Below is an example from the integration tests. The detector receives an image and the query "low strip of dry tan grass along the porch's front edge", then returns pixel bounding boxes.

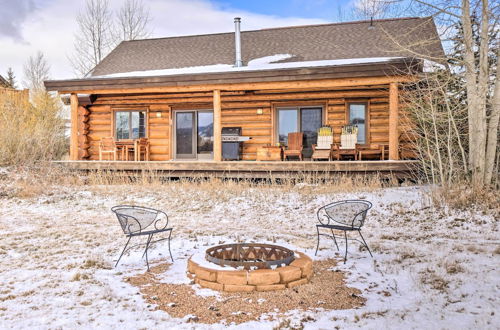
[0,162,394,198]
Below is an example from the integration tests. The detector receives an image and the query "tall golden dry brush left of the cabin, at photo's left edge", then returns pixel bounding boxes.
[0,92,68,166]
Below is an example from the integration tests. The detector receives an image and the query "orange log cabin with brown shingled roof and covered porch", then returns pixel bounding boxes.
[45,17,443,175]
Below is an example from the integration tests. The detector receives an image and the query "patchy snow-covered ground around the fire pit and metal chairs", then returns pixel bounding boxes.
[0,183,500,329]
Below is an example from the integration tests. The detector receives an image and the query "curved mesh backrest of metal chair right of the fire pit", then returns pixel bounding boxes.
[317,200,372,228]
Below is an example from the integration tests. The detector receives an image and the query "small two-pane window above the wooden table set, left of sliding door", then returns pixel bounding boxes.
[115,111,146,140]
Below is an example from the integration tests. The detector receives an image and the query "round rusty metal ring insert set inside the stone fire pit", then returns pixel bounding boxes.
[205,243,295,270]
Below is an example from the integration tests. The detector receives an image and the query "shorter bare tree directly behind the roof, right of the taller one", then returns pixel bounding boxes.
[118,0,151,40]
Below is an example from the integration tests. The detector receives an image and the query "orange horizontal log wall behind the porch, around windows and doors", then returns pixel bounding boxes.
[89,86,404,160]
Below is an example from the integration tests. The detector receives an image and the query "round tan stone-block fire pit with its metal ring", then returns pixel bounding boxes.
[188,243,313,292]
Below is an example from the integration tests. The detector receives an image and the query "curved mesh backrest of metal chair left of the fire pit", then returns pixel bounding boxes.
[111,205,168,235]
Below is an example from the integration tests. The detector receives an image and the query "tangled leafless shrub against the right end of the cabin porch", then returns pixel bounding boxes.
[401,71,469,185]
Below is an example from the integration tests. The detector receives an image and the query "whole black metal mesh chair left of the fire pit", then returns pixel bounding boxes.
[111,205,174,271]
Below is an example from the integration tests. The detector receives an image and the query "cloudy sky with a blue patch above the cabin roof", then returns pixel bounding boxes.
[0,0,384,87]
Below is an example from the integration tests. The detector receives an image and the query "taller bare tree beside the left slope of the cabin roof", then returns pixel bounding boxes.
[70,0,116,76]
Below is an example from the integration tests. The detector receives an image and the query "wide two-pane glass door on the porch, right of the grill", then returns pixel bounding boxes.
[278,107,322,157]
